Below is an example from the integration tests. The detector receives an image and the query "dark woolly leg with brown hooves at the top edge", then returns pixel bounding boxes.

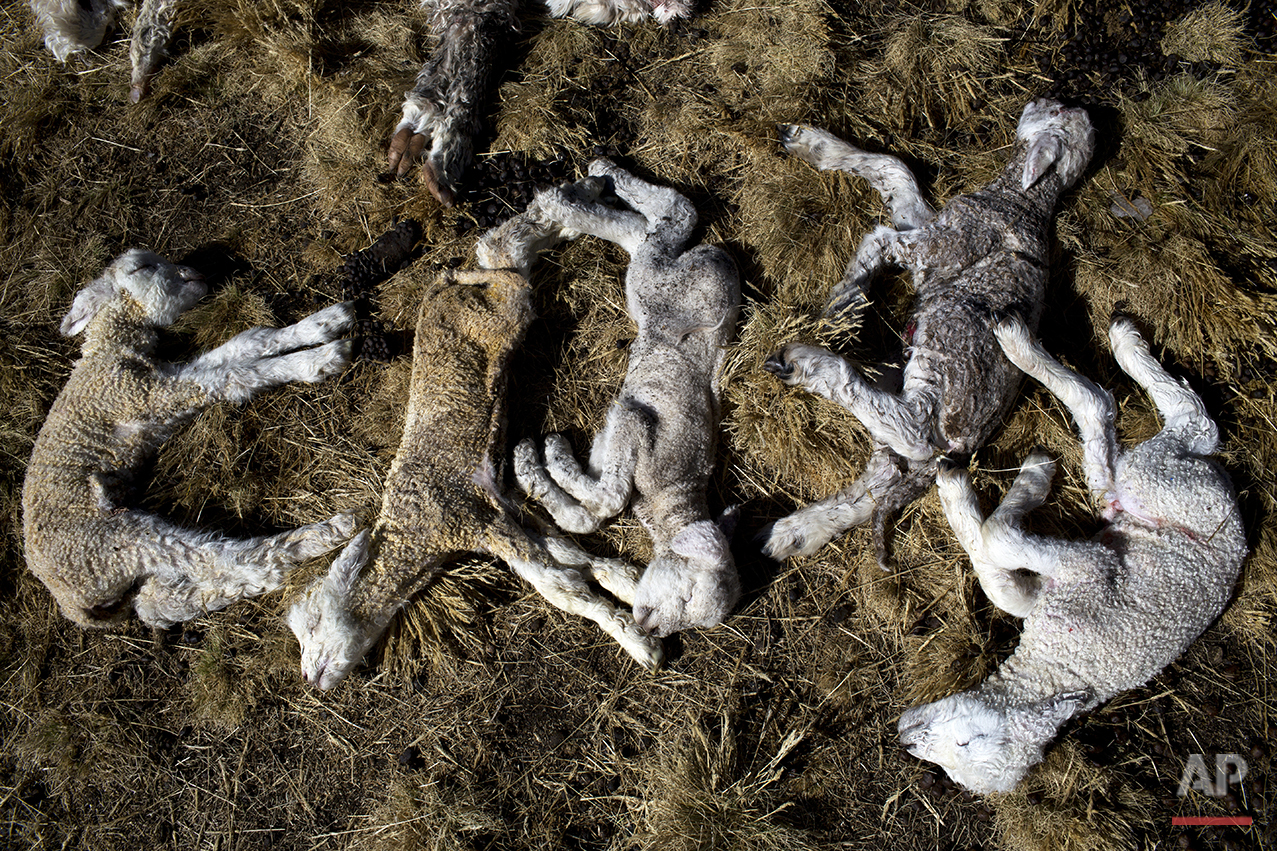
[387,0,518,207]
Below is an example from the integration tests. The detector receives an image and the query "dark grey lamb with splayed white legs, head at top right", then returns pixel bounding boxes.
[761,100,1094,570]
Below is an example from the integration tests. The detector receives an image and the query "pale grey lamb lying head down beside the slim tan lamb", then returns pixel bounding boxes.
[515,160,741,636]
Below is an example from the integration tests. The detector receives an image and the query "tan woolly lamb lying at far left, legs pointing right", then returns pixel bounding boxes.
[22,249,355,627]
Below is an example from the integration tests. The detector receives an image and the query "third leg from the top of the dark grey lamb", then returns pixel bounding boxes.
[762,344,935,461]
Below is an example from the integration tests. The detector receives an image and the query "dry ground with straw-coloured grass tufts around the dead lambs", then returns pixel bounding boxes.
[0,0,1277,851]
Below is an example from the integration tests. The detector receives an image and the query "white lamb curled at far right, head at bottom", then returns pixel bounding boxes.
[899,318,1246,792]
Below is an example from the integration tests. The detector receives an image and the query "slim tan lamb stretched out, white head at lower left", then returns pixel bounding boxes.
[289,181,663,690]
